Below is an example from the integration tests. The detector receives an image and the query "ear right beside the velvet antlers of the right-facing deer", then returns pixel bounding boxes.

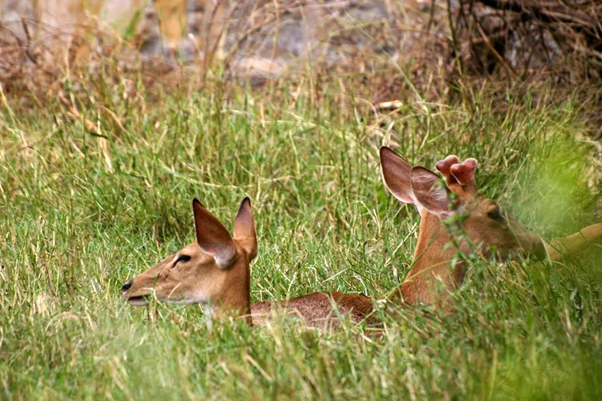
[411,166,451,218]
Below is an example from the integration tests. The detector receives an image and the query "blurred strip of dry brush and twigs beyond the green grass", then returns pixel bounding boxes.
[0,0,602,102]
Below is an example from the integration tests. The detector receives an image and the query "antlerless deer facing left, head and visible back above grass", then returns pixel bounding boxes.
[121,197,372,328]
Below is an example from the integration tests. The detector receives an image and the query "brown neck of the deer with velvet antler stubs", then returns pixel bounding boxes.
[400,209,466,304]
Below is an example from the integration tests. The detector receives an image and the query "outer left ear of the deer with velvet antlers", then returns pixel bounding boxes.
[380,146,415,203]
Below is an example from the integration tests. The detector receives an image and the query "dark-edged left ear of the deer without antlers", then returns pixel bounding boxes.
[192,199,236,268]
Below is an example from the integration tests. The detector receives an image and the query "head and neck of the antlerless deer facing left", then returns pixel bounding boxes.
[121,198,257,323]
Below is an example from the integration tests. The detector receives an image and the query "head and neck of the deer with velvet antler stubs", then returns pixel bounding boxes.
[380,147,546,303]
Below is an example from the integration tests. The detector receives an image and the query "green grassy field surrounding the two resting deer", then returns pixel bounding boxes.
[0,72,602,400]
